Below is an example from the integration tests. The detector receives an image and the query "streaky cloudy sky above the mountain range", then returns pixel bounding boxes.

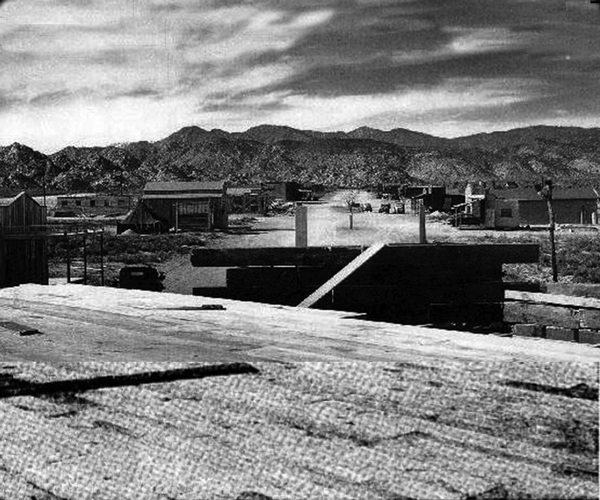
[0,0,600,152]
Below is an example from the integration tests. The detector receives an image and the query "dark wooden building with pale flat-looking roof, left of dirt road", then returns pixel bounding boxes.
[142,181,228,231]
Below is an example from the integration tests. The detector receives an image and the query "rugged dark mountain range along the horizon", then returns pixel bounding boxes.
[0,125,600,195]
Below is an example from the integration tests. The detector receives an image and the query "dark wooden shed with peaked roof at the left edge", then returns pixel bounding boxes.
[0,192,48,287]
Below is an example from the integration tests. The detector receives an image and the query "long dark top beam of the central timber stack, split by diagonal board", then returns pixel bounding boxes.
[191,243,539,267]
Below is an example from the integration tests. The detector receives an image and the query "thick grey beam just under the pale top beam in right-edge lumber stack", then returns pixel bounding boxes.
[504,302,579,328]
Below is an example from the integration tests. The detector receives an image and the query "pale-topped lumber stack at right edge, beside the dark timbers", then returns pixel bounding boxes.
[504,290,600,344]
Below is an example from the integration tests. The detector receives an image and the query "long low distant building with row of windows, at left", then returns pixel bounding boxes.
[51,193,134,217]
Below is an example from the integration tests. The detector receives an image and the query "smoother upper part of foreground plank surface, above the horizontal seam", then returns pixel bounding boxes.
[0,285,600,362]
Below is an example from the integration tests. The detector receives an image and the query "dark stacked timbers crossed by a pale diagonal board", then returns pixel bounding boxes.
[191,244,539,325]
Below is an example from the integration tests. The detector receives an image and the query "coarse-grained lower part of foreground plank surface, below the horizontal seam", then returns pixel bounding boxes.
[0,356,598,500]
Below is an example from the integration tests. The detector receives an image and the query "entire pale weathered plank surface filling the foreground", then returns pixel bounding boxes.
[0,285,599,500]
